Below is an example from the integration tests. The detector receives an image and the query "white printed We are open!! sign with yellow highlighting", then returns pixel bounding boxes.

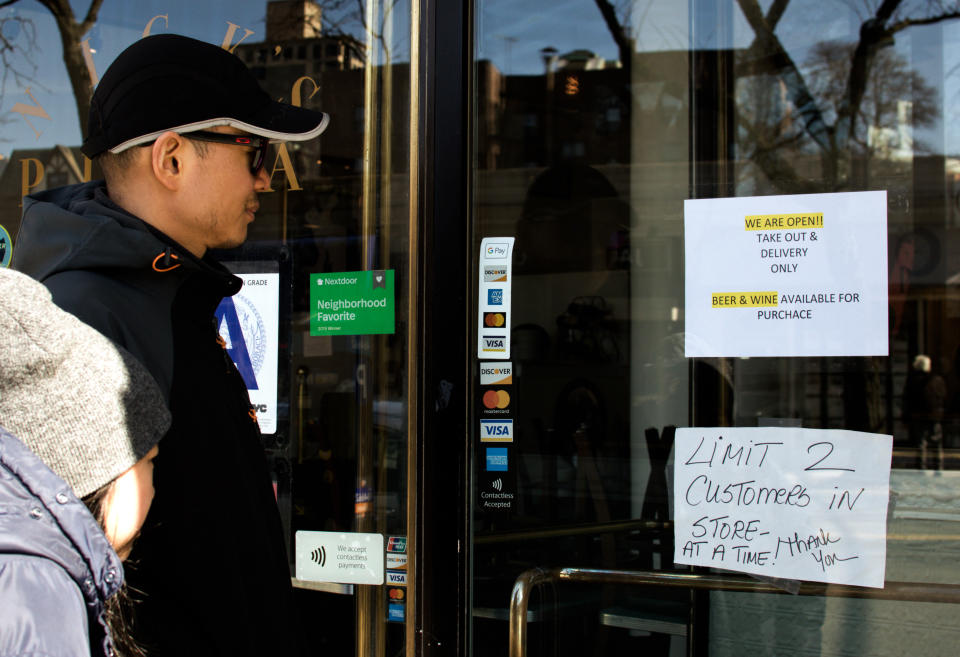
[684,191,888,357]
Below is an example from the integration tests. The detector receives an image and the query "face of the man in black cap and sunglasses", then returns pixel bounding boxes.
[181,127,270,252]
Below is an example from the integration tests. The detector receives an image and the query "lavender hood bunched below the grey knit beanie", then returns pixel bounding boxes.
[0,427,123,606]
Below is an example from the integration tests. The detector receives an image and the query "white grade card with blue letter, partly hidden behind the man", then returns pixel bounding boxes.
[216,273,280,434]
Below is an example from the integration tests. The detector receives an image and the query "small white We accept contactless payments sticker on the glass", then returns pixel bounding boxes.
[294,531,383,584]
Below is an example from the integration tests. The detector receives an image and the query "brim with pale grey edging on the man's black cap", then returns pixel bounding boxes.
[110,101,330,153]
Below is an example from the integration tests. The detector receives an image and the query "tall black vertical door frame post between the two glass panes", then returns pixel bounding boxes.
[406,0,473,656]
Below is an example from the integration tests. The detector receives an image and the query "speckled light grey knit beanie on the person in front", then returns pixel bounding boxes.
[0,269,170,497]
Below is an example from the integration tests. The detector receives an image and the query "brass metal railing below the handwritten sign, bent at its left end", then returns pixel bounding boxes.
[510,568,960,657]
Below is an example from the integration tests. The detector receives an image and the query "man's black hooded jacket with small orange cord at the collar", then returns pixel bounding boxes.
[13,181,298,657]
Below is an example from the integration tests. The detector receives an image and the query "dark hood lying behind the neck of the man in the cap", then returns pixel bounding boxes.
[14,180,170,280]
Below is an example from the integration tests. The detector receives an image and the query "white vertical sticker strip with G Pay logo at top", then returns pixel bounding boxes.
[477,237,514,360]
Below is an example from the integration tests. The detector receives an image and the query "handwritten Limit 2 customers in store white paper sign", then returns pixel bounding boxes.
[673,427,893,588]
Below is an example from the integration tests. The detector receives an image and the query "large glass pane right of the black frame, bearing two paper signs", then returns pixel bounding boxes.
[471,0,960,655]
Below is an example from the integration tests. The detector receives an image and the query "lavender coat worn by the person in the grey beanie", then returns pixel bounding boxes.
[0,427,123,657]
